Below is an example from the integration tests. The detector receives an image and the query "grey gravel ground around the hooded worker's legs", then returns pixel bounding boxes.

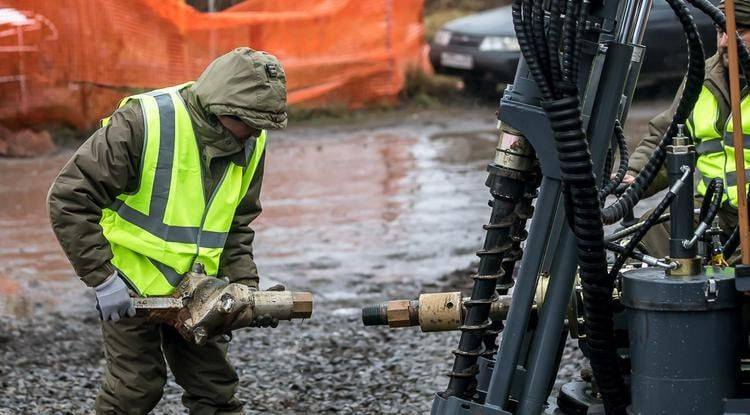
[0,272,581,414]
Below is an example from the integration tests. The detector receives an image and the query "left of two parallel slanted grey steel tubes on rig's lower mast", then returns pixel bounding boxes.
[486,177,562,408]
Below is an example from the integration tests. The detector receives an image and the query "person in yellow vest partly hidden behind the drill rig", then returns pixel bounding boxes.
[623,0,750,259]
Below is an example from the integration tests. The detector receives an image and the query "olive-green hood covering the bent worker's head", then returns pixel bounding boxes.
[186,47,287,158]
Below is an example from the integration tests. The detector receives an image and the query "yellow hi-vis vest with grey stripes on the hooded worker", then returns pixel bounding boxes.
[100,83,266,296]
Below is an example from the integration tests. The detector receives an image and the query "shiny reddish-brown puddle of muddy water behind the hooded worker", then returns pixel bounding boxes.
[0,118,506,315]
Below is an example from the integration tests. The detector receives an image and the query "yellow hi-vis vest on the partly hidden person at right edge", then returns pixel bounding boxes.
[687,85,750,208]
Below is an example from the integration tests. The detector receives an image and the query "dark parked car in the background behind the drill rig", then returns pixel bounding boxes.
[430,0,716,92]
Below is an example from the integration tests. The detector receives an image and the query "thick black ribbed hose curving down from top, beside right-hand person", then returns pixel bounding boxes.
[602,0,705,225]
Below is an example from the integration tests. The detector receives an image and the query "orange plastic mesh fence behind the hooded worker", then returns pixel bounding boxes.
[0,0,423,128]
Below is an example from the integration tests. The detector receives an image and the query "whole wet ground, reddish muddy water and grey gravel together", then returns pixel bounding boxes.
[0,97,667,414]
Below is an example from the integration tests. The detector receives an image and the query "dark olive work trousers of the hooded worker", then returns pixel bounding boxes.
[96,317,243,415]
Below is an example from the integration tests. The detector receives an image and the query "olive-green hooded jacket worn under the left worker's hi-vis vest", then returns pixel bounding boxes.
[47,48,286,287]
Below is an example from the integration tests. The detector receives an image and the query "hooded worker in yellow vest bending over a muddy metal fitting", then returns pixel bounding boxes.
[49,48,286,414]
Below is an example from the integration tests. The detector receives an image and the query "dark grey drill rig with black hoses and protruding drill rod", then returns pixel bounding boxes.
[363,0,750,415]
